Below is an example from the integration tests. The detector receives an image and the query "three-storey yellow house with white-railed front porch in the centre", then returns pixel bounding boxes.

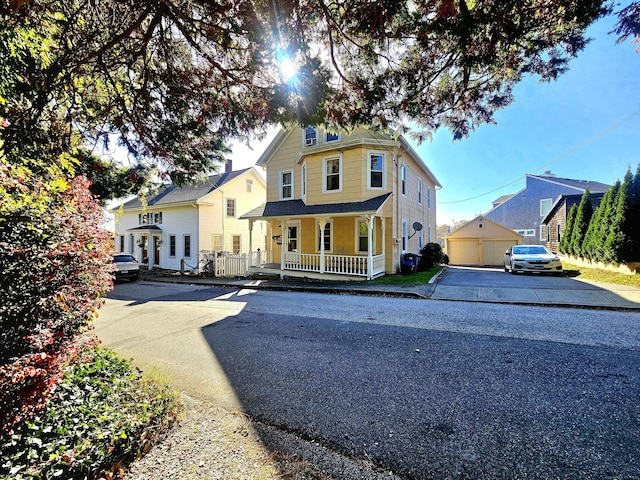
[243,127,440,279]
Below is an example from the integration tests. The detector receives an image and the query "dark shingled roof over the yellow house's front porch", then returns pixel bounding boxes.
[240,193,391,219]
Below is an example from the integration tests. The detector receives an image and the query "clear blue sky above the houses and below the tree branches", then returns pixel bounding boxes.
[230,9,640,224]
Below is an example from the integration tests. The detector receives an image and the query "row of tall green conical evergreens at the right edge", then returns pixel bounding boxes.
[558,165,640,264]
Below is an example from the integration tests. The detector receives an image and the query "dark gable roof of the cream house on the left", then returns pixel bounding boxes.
[123,167,262,210]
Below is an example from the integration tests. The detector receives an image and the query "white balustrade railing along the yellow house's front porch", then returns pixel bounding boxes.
[284,253,384,278]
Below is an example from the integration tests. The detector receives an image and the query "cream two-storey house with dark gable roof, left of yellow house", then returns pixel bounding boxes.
[112,161,266,272]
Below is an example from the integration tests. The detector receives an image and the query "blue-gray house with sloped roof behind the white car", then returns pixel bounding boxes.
[484,171,610,245]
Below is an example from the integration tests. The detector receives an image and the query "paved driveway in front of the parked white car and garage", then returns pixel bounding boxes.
[431,266,640,309]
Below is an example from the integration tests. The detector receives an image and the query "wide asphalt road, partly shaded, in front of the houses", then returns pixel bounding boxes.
[96,284,640,479]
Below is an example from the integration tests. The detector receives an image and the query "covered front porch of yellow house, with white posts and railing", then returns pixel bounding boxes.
[243,195,388,280]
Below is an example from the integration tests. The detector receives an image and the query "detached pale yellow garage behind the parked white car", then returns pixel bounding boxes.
[444,216,522,266]
